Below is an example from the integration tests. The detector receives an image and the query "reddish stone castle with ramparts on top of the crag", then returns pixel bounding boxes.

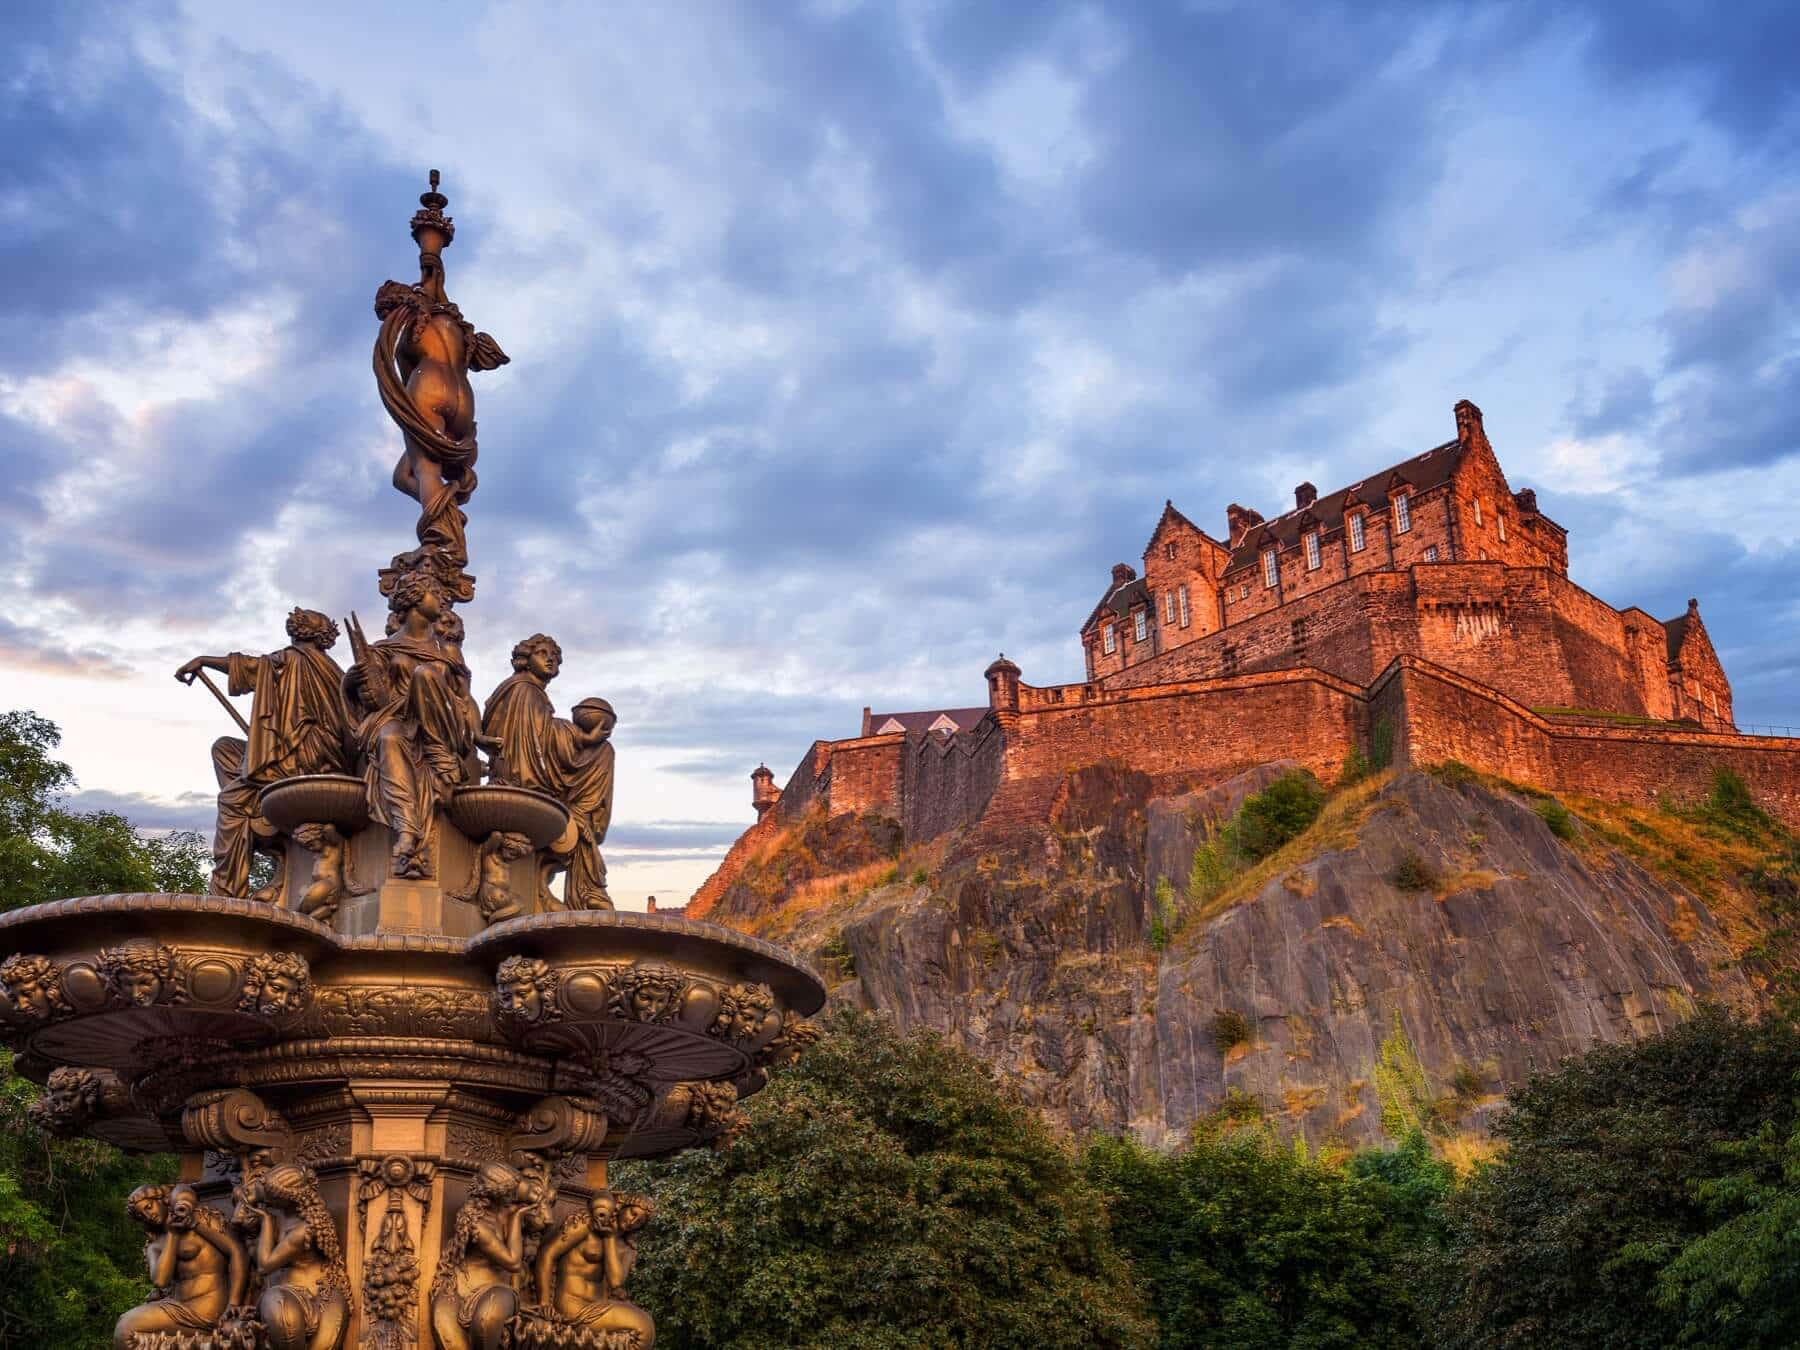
[695,401,1778,913]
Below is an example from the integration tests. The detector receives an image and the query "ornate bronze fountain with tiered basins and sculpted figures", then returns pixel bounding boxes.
[0,171,824,1350]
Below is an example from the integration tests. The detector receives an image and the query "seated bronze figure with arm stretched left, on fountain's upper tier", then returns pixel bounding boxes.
[175,608,351,896]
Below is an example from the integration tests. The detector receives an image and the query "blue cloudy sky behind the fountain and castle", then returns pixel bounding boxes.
[0,0,1800,905]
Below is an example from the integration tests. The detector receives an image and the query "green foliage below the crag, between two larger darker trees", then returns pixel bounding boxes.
[1085,1129,1451,1350]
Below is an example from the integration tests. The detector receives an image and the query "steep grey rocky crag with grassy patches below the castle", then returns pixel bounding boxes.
[706,763,1791,1147]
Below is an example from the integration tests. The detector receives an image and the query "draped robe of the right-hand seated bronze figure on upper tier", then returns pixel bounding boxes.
[481,671,614,909]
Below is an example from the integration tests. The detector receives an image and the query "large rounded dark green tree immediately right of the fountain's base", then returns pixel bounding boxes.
[616,1013,1154,1350]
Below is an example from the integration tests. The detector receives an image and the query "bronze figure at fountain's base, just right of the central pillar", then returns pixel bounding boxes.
[430,1163,538,1350]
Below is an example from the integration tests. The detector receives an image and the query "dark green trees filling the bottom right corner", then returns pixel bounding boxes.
[1436,1010,1800,1350]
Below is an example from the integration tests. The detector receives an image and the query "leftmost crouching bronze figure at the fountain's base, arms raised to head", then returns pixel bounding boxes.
[113,1184,250,1350]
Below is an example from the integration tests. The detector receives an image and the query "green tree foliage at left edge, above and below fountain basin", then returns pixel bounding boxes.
[0,713,205,1346]
